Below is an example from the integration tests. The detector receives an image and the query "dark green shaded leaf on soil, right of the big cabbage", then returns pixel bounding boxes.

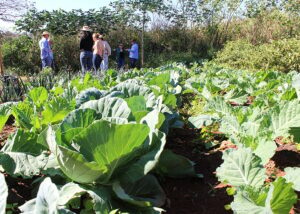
[155,150,203,178]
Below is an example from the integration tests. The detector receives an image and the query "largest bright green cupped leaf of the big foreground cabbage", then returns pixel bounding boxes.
[52,121,149,183]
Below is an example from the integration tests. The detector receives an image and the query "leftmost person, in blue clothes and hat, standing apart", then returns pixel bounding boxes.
[39,31,52,68]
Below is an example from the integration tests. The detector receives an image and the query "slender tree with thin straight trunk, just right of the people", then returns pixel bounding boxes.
[111,0,169,66]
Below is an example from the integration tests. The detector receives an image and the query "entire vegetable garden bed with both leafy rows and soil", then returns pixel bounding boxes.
[0,65,300,214]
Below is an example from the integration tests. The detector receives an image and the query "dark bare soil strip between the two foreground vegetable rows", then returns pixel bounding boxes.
[162,129,233,214]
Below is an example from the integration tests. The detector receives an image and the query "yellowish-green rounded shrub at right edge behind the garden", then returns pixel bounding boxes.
[213,38,300,72]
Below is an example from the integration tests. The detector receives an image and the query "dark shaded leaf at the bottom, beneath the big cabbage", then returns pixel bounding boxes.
[113,175,166,207]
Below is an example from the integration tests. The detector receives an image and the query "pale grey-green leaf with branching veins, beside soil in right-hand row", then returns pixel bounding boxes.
[217,148,266,187]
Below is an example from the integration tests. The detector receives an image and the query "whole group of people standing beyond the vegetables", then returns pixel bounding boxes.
[39,26,139,74]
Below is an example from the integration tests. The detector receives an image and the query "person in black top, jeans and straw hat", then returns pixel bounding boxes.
[79,26,94,74]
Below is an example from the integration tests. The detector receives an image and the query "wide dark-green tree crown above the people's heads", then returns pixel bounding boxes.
[16,7,118,35]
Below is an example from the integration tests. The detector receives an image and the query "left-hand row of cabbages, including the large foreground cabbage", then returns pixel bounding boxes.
[0,69,199,214]
